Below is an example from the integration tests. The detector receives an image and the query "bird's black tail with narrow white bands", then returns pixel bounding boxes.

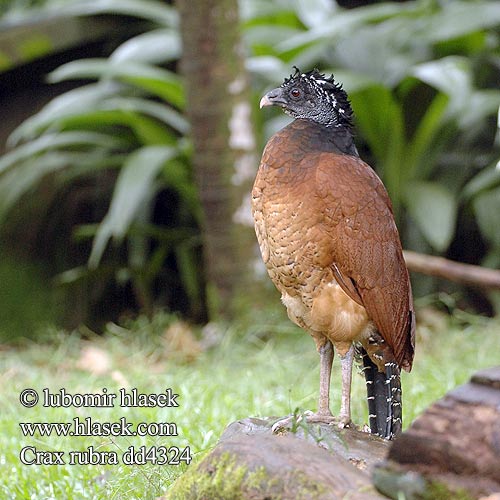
[360,348,403,439]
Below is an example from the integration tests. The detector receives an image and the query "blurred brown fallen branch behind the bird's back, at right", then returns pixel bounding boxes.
[404,250,500,289]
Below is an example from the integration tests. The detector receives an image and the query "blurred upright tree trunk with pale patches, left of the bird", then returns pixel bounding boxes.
[177,0,257,319]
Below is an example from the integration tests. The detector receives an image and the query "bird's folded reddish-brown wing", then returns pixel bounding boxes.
[316,153,414,370]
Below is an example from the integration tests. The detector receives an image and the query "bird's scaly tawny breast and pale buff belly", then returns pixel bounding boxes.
[252,153,370,350]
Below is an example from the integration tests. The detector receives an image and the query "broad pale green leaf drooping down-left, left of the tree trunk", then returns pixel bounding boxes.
[89,146,177,268]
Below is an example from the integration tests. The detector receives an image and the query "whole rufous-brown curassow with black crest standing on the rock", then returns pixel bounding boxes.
[252,68,415,439]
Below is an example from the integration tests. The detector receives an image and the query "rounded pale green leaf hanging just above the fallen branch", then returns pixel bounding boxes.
[405,182,457,252]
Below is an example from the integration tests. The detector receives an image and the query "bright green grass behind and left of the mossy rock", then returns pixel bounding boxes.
[0,312,500,500]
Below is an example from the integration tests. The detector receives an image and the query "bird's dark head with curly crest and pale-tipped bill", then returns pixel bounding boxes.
[260,67,352,129]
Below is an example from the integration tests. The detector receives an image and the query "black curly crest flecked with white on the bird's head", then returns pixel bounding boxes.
[281,66,354,129]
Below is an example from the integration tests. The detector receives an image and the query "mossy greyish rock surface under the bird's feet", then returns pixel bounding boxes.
[167,419,388,500]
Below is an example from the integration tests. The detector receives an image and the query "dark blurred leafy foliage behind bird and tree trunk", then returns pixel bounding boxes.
[0,0,500,335]
